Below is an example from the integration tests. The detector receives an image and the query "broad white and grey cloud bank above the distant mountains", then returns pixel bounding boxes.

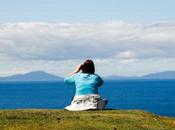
[0,21,175,75]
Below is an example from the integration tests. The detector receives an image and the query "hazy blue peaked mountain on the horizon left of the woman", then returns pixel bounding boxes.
[0,71,63,81]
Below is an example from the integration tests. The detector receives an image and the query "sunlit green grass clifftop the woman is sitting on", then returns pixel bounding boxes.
[0,109,175,130]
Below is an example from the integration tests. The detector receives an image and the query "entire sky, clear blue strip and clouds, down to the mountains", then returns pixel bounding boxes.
[0,0,175,76]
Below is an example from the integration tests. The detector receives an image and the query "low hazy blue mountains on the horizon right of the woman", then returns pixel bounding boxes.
[105,71,175,80]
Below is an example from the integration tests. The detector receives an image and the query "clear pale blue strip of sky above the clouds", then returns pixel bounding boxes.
[0,0,175,23]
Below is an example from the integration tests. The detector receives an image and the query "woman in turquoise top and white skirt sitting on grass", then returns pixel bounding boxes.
[64,60,107,111]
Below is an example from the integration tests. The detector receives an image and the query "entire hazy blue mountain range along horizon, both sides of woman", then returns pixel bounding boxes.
[0,71,175,82]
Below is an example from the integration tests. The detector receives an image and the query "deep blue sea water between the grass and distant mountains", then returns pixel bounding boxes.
[0,80,175,117]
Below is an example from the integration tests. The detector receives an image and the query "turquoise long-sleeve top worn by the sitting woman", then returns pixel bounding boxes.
[64,73,103,95]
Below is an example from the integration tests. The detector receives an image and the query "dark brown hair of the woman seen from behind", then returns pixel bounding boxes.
[81,59,95,74]
